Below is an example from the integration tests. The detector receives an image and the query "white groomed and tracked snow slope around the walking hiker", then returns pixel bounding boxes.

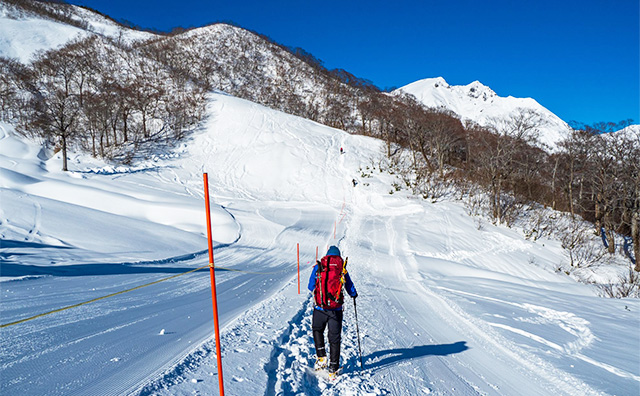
[0,94,640,396]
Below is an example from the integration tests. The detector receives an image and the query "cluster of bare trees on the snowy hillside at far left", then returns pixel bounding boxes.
[0,36,205,170]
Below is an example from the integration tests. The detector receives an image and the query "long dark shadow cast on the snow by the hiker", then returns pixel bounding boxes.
[363,341,469,369]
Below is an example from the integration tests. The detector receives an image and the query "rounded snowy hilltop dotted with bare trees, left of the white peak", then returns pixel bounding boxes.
[149,23,357,114]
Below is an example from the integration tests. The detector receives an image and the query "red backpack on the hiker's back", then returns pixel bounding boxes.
[314,256,345,309]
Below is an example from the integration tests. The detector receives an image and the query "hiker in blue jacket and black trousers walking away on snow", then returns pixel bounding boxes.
[309,246,358,379]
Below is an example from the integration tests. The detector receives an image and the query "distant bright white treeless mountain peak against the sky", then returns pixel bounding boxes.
[398,77,569,150]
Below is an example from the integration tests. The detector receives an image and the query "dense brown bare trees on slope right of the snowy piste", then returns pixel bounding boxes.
[370,100,640,282]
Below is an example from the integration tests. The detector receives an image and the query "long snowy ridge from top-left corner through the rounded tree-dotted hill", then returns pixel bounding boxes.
[0,0,363,132]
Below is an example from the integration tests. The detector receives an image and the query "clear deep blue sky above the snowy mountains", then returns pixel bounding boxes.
[70,0,640,124]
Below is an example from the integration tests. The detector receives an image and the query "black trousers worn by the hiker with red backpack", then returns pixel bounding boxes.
[311,309,342,370]
